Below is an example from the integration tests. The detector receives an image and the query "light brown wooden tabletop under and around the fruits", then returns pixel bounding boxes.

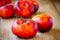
[0,0,60,40]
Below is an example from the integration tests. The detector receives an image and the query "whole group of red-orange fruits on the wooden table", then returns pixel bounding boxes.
[0,0,53,38]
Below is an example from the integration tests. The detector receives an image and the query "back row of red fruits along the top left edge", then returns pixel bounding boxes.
[0,0,39,18]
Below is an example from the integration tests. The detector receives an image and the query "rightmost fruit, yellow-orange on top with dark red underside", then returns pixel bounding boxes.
[32,14,53,32]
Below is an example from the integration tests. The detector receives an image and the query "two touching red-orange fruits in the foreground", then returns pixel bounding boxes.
[12,14,53,38]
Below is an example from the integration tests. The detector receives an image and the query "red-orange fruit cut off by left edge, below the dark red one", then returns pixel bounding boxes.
[0,3,13,18]
